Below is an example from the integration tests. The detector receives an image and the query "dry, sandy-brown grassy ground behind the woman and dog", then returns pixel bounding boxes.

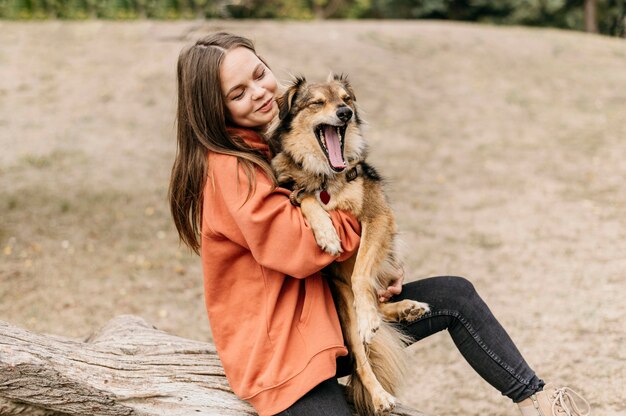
[0,21,626,416]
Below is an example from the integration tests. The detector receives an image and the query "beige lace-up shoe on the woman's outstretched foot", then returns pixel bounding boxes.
[518,384,591,416]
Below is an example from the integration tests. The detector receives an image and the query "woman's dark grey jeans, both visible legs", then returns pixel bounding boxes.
[272,276,544,416]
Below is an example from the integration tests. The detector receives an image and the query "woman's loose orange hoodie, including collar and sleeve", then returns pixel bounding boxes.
[201,129,360,416]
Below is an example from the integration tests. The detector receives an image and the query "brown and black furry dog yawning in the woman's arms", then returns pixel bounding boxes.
[270,75,428,415]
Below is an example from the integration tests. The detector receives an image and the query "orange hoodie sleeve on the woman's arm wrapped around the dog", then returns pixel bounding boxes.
[203,155,361,278]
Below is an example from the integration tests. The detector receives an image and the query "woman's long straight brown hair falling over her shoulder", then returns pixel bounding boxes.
[168,32,276,254]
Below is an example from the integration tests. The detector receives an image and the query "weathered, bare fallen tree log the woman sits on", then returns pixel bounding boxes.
[0,315,424,416]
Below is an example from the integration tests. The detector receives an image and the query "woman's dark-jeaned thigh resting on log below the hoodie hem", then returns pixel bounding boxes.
[276,377,352,416]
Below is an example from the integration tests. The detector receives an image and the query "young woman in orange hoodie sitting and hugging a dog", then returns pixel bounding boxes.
[169,33,588,416]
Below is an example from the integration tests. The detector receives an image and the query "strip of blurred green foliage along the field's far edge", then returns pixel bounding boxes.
[0,0,626,36]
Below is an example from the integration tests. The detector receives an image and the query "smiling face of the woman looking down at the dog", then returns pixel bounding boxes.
[220,47,278,127]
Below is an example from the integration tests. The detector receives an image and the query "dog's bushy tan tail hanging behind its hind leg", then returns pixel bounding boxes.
[348,322,410,415]
